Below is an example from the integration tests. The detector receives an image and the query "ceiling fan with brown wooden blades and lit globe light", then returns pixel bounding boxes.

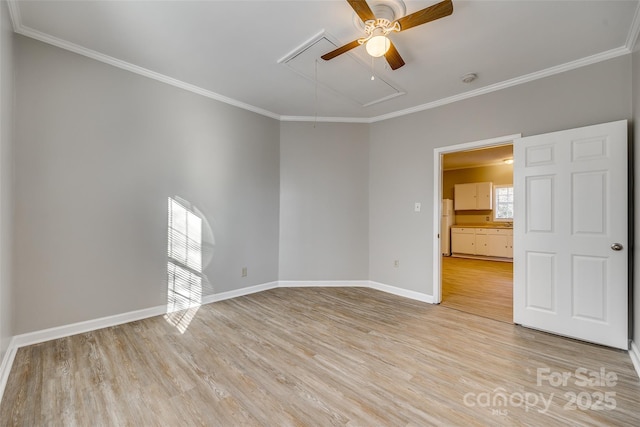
[321,0,453,70]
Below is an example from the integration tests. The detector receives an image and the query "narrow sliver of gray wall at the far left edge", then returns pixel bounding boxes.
[0,1,13,360]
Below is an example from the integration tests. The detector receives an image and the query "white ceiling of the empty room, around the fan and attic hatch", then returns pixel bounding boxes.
[10,0,640,122]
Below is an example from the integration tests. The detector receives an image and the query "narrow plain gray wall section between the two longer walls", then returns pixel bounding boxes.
[280,123,369,280]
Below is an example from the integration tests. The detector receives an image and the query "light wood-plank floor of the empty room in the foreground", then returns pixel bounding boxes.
[0,288,640,427]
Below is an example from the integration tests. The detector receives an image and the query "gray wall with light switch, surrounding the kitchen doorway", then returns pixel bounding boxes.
[369,55,631,294]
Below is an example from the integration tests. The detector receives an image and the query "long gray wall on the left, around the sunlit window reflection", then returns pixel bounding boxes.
[14,36,280,334]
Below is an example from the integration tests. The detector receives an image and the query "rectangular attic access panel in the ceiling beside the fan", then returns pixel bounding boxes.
[278,33,404,107]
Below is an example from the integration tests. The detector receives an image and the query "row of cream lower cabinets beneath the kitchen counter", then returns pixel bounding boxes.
[451,227,513,258]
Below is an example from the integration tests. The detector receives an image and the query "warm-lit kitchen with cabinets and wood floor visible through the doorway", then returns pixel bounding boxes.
[440,144,514,323]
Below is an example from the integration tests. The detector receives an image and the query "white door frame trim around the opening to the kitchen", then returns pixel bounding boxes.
[433,133,522,304]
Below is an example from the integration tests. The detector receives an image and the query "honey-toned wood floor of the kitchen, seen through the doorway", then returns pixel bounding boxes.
[441,257,513,323]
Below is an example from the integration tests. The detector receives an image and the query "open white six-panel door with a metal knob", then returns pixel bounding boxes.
[513,121,629,349]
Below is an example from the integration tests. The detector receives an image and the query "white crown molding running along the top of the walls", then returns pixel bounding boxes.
[7,0,640,124]
